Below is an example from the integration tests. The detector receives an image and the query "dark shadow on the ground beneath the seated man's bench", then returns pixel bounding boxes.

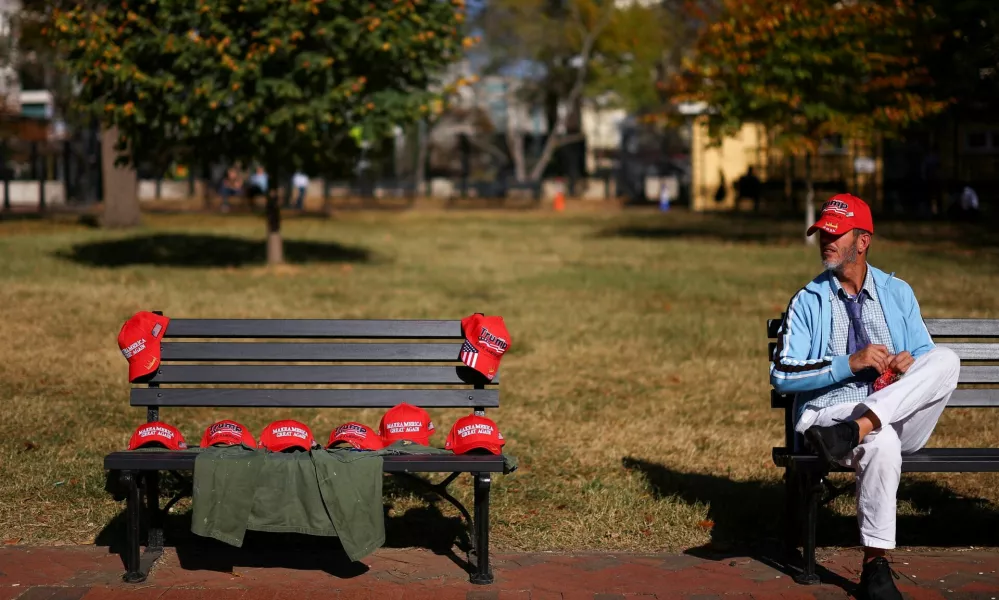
[621,457,999,593]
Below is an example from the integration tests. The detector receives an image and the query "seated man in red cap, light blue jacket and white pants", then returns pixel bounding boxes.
[770,194,960,599]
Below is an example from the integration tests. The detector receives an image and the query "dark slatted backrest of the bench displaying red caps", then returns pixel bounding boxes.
[130,319,499,421]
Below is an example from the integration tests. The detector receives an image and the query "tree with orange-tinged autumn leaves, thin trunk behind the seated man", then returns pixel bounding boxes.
[668,0,949,239]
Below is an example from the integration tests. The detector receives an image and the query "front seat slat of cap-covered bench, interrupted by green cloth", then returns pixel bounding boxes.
[104,451,503,473]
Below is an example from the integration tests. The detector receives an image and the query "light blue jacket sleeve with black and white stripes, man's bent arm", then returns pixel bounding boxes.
[770,289,853,393]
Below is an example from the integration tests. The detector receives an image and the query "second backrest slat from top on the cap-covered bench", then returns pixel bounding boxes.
[162,342,461,362]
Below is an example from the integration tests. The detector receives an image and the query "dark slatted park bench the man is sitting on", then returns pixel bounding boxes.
[767,315,999,584]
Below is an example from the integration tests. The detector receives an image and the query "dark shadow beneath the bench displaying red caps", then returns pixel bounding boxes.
[95,477,474,579]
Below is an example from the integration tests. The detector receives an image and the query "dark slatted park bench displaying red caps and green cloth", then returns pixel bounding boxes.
[104,319,504,584]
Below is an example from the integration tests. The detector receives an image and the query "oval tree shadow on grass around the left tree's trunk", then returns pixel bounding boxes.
[56,233,371,267]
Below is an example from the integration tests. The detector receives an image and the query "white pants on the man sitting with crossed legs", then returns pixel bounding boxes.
[795,347,961,550]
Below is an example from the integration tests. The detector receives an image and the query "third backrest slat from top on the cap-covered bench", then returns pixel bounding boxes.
[149,365,499,385]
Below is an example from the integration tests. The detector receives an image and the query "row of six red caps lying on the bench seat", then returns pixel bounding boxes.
[128,402,506,454]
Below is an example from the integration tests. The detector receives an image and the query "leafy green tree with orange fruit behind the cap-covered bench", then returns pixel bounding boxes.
[46,0,464,264]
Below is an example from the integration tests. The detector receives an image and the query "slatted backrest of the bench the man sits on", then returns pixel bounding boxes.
[767,314,999,449]
